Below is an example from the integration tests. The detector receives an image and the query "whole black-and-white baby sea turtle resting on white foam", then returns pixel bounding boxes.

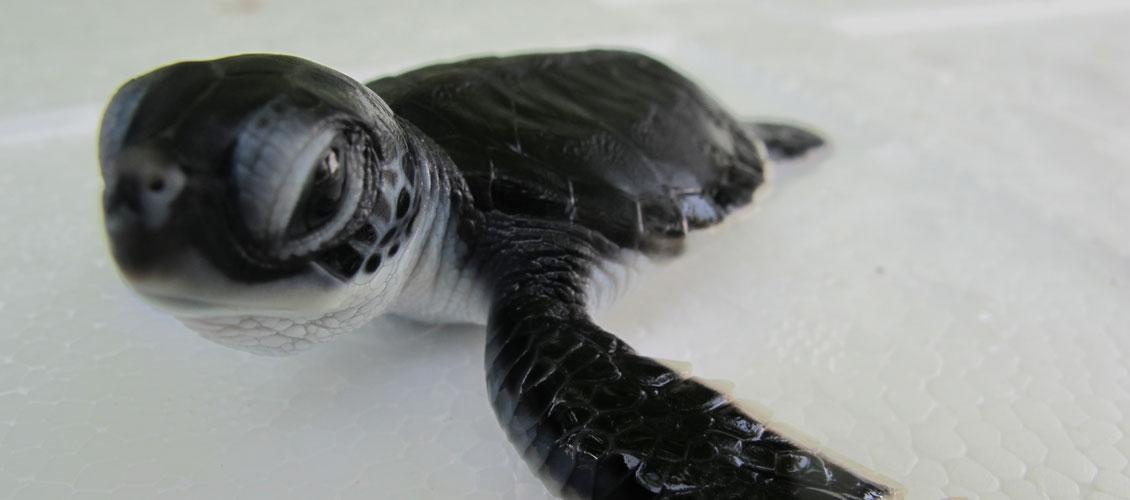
[98,51,890,499]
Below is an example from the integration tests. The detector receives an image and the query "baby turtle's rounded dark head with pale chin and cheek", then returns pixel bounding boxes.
[98,54,421,353]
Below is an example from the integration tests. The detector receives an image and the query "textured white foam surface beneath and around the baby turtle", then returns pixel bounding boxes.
[0,0,1130,499]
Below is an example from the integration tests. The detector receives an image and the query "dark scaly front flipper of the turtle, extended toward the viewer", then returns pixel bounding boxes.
[476,215,890,499]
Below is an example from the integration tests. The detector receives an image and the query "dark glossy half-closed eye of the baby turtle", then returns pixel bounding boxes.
[287,147,348,236]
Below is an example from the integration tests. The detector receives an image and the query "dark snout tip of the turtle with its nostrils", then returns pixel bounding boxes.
[103,143,186,281]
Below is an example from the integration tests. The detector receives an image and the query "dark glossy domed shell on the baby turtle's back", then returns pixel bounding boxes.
[367,51,764,253]
